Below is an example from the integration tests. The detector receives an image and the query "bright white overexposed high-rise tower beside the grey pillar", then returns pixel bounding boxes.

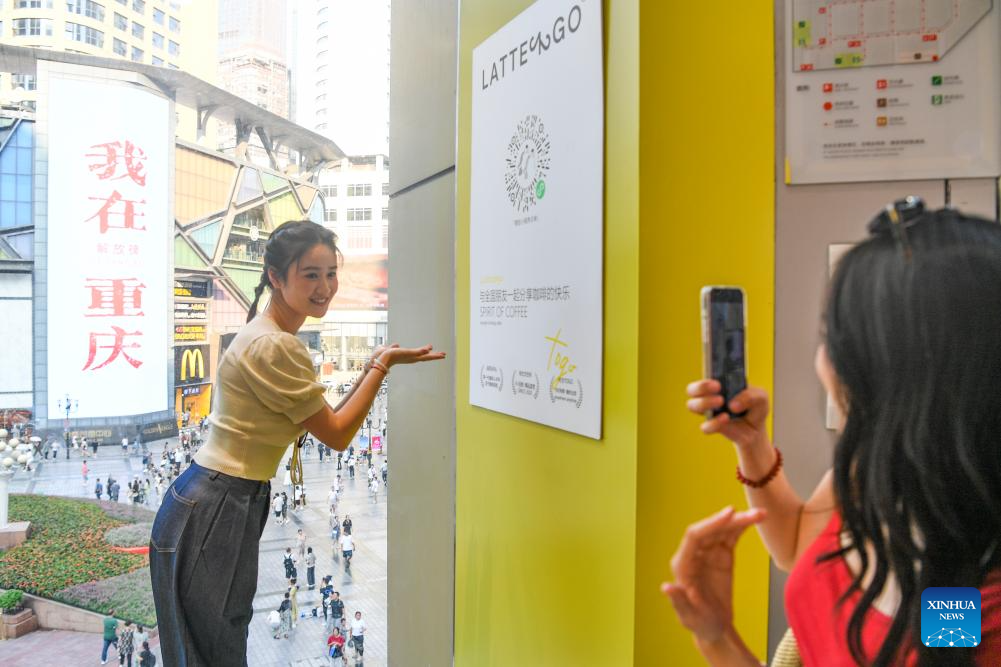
[288,0,389,155]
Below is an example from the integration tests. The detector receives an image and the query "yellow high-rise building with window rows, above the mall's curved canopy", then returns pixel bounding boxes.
[0,0,217,106]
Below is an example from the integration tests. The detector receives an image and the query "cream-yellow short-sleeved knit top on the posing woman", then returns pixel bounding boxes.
[194,315,326,481]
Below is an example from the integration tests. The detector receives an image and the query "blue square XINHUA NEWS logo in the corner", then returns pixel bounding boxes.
[921,587,981,648]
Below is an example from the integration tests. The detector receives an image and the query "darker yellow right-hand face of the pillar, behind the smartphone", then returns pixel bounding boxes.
[636,1,775,665]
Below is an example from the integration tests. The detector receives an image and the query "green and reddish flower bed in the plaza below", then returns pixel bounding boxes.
[0,494,155,625]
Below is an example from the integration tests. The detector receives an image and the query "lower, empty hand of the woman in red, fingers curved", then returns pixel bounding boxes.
[661,507,765,644]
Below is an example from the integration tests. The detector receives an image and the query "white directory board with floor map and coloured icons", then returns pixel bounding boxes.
[786,0,1001,183]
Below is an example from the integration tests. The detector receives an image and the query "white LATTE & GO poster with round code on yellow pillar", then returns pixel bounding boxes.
[469,0,605,439]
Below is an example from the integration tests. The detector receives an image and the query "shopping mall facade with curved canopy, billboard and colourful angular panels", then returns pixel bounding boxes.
[0,45,344,442]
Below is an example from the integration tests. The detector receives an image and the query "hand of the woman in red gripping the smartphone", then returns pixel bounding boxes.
[686,379,769,447]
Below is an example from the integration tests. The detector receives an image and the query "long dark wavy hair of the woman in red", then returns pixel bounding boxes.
[824,209,1001,666]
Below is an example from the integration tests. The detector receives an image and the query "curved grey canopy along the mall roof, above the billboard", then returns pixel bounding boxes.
[0,44,344,171]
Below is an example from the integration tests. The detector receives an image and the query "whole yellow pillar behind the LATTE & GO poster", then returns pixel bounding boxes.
[454,0,774,667]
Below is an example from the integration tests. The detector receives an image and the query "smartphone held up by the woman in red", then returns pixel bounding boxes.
[702,286,748,419]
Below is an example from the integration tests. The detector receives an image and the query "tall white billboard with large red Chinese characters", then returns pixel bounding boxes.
[47,72,173,419]
